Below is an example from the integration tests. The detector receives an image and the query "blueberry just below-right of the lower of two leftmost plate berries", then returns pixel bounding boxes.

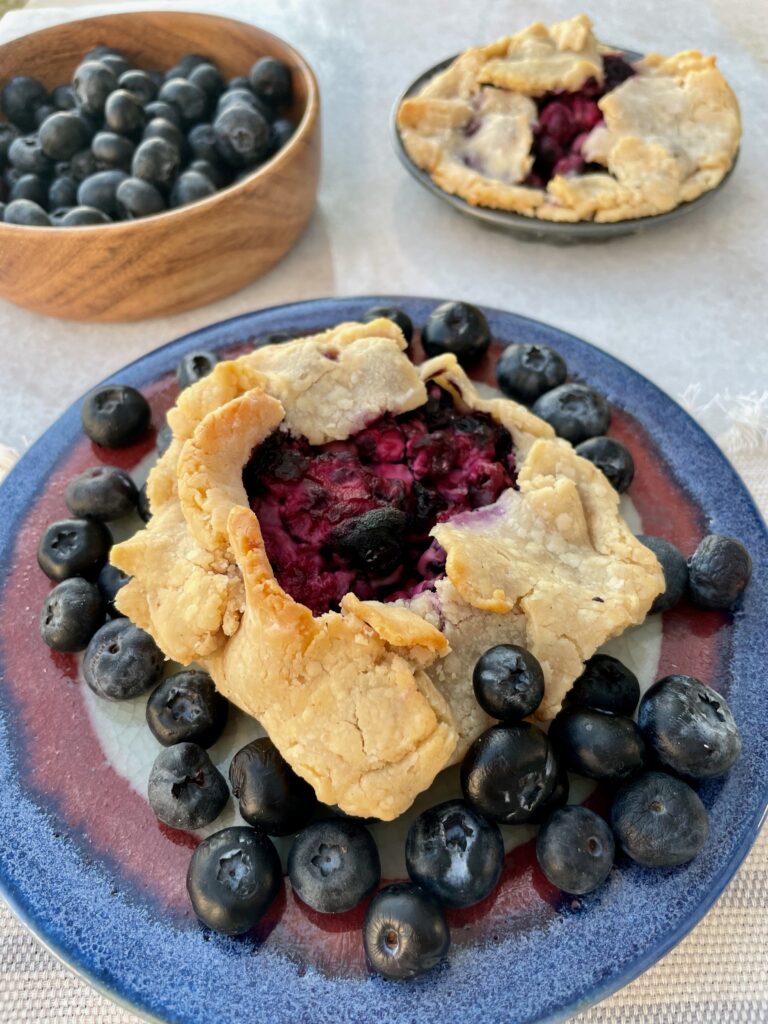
[83,618,165,700]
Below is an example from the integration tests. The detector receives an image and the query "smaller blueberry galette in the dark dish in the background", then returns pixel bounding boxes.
[397,14,741,221]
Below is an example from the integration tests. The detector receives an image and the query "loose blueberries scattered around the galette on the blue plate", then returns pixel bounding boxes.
[38,303,752,979]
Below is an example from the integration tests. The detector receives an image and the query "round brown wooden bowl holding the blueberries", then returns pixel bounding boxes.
[0,11,319,321]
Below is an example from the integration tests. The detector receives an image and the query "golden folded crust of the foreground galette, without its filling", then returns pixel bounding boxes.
[112,319,664,820]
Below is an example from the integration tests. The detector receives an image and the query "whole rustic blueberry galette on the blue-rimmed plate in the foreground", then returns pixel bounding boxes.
[112,319,664,819]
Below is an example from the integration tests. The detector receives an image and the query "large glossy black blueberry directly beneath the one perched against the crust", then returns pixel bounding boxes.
[461,722,558,825]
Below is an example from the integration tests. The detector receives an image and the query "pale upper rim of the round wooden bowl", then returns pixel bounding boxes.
[0,10,319,239]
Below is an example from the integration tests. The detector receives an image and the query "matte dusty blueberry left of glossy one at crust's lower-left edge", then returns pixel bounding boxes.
[146,743,229,828]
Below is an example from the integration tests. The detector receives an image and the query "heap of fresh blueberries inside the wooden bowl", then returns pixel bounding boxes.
[0,46,295,227]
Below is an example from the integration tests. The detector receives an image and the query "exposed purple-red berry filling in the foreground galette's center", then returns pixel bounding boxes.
[243,384,515,614]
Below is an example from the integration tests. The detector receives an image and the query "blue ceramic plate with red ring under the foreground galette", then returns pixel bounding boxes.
[0,297,768,1024]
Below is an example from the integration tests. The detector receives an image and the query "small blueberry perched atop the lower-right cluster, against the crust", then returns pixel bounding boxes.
[472,643,544,722]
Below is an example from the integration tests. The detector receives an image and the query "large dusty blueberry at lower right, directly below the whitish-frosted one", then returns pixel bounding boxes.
[610,771,710,867]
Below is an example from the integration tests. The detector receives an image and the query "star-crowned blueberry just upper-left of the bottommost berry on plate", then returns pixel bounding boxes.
[288,818,381,913]
